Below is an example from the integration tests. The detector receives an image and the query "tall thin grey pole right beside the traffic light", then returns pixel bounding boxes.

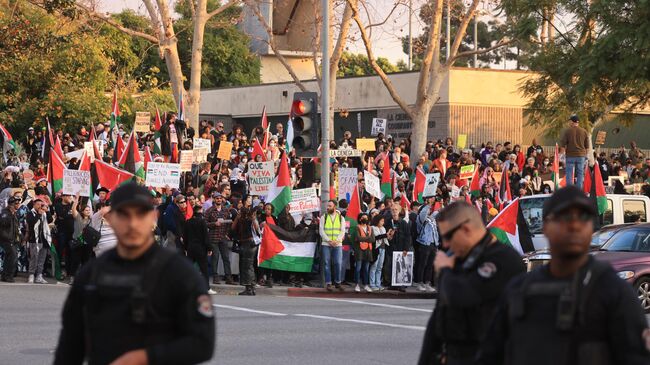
[320,0,330,212]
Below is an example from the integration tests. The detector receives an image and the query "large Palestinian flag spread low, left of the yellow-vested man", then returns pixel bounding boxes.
[257,224,318,272]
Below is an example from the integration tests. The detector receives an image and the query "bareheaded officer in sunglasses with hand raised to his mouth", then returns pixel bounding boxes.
[419,201,525,365]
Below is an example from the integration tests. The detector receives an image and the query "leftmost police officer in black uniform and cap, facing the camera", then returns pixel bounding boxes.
[54,183,215,365]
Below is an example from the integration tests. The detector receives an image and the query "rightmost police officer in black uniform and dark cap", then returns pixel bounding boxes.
[477,186,650,365]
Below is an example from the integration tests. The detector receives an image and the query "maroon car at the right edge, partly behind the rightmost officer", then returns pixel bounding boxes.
[592,223,650,313]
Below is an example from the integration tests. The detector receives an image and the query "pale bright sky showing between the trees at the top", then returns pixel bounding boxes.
[93,0,422,63]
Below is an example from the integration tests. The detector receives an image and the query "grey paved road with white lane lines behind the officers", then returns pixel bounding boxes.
[0,284,434,365]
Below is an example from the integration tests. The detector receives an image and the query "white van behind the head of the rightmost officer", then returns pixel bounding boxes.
[519,194,650,250]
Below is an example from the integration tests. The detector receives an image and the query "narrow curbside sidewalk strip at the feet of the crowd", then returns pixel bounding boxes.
[210,284,437,299]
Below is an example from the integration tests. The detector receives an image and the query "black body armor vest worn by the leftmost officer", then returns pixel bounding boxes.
[83,248,175,365]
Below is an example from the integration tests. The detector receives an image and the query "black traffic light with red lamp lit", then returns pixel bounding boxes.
[289,92,320,157]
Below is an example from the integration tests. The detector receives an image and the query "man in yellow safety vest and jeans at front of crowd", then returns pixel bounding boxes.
[319,200,345,291]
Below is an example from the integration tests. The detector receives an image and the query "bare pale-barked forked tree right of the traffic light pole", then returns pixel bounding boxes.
[347,0,510,165]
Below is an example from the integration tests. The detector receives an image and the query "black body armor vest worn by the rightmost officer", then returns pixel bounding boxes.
[506,257,611,365]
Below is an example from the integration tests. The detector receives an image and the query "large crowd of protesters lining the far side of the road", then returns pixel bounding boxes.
[0,113,650,295]
